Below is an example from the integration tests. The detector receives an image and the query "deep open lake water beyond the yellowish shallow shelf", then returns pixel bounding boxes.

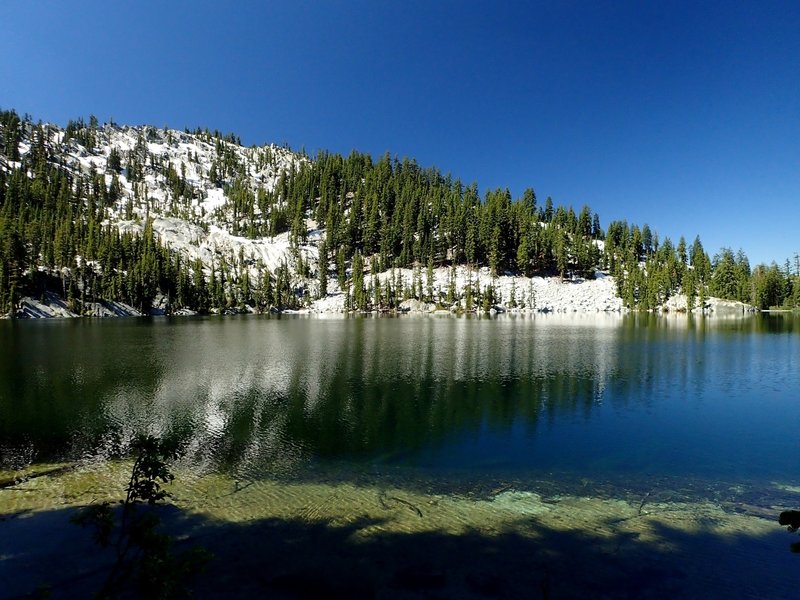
[0,315,800,480]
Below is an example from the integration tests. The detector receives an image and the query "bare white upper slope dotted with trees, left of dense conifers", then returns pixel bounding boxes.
[65,125,317,282]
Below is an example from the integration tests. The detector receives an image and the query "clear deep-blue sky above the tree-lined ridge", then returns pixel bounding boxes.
[0,0,800,264]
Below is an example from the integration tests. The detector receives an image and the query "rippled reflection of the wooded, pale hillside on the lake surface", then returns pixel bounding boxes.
[0,315,797,476]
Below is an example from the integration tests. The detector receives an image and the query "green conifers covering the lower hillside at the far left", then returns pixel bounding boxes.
[0,113,203,313]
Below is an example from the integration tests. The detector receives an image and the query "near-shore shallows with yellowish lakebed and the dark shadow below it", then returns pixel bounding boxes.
[0,461,800,598]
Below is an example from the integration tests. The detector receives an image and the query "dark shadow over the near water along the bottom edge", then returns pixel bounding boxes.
[0,506,798,598]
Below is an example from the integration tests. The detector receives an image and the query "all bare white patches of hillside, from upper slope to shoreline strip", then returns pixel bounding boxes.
[0,113,752,317]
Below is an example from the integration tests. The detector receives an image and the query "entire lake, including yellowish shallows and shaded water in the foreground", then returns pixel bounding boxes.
[0,314,800,597]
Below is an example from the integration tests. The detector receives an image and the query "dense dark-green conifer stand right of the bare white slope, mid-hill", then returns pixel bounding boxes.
[259,152,603,277]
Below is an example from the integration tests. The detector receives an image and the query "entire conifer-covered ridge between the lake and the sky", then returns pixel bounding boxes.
[0,110,800,314]
